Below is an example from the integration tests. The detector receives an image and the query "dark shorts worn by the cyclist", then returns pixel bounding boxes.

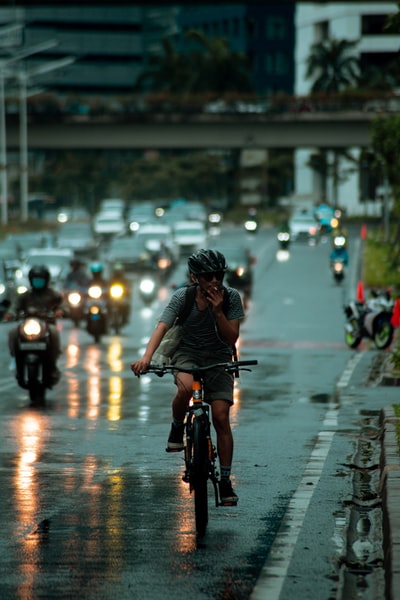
[172,350,234,404]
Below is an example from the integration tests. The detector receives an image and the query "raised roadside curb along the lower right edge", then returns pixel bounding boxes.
[380,407,400,600]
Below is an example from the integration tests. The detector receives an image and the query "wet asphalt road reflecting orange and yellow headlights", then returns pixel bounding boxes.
[0,230,372,600]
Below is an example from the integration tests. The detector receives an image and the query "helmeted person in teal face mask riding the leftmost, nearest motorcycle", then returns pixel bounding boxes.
[4,265,63,383]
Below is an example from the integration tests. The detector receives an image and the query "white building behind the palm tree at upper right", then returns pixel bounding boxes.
[295,0,400,216]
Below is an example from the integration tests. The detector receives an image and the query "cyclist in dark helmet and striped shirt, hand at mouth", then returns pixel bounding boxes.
[131,250,244,504]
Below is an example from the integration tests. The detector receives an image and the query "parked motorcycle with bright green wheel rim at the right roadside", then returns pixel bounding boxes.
[343,292,394,350]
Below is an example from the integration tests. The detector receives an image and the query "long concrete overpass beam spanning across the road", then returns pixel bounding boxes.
[7,111,376,150]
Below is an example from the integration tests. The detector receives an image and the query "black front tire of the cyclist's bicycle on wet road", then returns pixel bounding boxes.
[192,418,208,537]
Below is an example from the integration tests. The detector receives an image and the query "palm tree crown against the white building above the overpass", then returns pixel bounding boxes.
[306,39,359,92]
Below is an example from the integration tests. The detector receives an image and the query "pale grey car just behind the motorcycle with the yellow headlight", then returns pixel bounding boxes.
[105,235,155,272]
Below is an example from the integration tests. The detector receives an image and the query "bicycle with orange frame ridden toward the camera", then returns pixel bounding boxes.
[147,360,258,537]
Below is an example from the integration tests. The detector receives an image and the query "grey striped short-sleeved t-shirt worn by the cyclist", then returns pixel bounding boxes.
[160,287,244,353]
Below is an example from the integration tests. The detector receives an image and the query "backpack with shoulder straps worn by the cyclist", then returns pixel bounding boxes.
[153,284,237,365]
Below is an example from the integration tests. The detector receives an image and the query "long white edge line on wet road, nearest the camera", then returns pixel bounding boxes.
[250,407,338,600]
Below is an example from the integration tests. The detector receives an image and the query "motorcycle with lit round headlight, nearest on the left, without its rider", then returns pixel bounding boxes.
[15,308,59,404]
